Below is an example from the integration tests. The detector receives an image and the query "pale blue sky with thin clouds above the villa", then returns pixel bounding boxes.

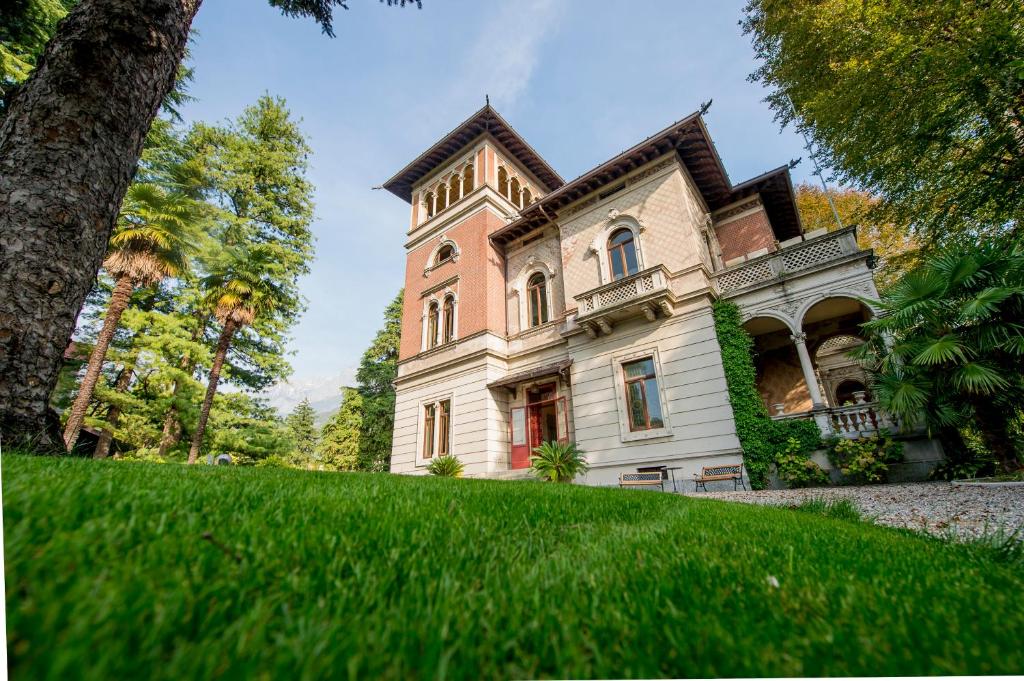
[176,0,811,406]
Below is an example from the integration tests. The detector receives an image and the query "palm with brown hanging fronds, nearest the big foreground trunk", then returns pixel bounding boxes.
[63,182,203,451]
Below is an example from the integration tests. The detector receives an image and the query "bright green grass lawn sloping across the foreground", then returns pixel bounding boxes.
[2,456,1024,679]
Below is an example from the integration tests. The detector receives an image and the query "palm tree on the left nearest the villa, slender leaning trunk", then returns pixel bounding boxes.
[188,244,290,464]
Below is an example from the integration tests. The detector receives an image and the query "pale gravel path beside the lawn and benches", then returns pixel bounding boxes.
[685,482,1024,539]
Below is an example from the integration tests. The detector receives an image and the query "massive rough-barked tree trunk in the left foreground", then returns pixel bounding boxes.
[0,0,201,449]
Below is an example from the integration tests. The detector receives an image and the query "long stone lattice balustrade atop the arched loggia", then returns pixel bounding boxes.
[715,226,860,294]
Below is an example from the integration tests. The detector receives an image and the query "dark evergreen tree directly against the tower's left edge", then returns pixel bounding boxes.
[355,291,402,471]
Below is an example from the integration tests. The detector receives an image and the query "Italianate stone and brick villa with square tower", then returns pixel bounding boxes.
[384,104,905,484]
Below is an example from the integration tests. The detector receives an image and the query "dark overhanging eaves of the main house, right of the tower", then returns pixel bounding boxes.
[490,113,801,244]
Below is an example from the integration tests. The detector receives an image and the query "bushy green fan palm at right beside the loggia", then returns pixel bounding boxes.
[855,244,1024,470]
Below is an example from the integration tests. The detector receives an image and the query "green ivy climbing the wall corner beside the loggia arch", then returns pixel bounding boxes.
[714,300,821,490]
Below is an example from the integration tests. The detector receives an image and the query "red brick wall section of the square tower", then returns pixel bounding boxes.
[398,210,506,359]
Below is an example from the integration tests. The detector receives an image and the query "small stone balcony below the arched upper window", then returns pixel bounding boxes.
[575,265,672,338]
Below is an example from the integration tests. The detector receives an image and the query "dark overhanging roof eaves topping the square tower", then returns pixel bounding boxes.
[383,103,565,202]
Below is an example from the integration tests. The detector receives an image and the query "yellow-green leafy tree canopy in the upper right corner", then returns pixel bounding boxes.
[742,0,1024,245]
